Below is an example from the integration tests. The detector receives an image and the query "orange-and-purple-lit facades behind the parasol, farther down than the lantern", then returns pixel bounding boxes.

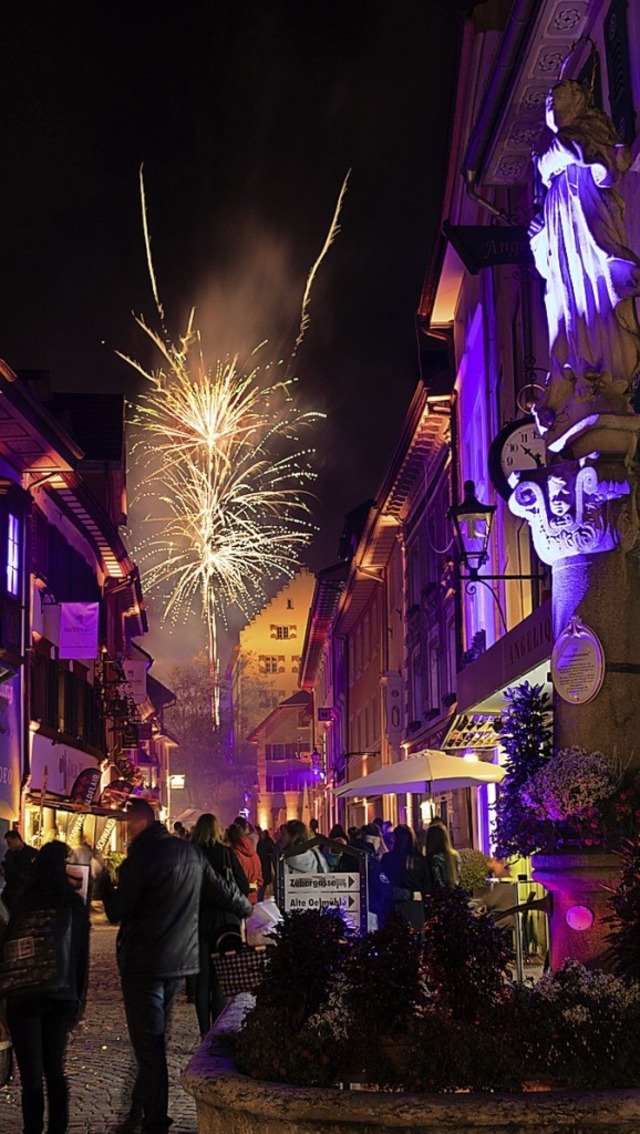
[301,383,490,846]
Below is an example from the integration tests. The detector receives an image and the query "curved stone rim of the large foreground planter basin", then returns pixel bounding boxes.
[182,997,640,1134]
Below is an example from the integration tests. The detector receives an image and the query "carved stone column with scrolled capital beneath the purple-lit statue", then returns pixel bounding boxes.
[510,456,640,764]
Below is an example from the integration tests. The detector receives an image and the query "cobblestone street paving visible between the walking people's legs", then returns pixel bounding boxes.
[0,921,200,1134]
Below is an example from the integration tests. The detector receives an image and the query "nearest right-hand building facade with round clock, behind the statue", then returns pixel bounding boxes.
[420,0,640,849]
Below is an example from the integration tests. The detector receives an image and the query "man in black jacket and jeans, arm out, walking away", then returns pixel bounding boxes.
[102,799,251,1134]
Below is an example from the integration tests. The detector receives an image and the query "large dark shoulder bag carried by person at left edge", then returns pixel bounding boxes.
[0,906,73,997]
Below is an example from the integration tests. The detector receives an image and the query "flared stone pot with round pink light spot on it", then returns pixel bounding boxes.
[531,852,621,972]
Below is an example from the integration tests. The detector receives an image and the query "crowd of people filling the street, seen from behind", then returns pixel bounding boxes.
[2,799,467,1134]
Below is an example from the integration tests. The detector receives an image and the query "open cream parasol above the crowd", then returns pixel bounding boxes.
[335,748,505,798]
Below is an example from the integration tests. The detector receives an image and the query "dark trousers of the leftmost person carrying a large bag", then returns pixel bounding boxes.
[7,997,77,1134]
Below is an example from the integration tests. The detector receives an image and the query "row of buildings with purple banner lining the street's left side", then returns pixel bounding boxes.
[0,363,177,849]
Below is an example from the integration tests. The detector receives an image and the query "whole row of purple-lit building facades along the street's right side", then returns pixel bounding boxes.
[301,0,640,875]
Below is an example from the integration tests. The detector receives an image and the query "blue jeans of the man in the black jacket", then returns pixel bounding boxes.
[121,976,184,1134]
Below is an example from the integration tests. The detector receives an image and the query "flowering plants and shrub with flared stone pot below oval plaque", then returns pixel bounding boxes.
[496,683,640,968]
